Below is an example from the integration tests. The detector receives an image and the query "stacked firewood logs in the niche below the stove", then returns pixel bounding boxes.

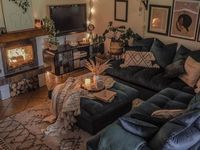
[10,76,39,97]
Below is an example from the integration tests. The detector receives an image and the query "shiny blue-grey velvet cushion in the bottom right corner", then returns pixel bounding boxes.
[149,110,200,150]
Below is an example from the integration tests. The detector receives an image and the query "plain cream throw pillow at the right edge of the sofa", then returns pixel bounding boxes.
[179,56,200,88]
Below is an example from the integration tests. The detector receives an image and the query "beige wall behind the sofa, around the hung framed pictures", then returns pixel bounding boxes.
[94,0,200,50]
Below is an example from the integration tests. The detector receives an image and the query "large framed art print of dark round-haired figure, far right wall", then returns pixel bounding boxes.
[170,0,200,41]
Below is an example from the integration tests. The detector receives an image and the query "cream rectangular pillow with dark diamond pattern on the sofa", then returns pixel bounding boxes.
[121,51,159,68]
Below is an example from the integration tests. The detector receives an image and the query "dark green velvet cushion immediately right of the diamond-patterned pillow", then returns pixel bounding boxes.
[150,39,177,68]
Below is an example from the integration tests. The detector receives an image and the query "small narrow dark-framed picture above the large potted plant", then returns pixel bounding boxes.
[114,0,128,22]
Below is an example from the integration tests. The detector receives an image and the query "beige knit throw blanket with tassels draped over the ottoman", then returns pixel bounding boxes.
[45,76,115,136]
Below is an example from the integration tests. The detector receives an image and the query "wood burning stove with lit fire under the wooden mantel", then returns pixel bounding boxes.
[1,38,38,76]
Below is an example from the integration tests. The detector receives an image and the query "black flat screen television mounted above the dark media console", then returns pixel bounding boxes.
[49,4,87,34]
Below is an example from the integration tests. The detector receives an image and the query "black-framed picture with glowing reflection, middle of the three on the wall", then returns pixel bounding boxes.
[148,5,171,35]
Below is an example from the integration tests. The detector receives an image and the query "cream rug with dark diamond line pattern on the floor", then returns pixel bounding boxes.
[0,103,90,150]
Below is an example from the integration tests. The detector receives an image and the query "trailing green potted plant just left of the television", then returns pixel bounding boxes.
[42,17,59,50]
